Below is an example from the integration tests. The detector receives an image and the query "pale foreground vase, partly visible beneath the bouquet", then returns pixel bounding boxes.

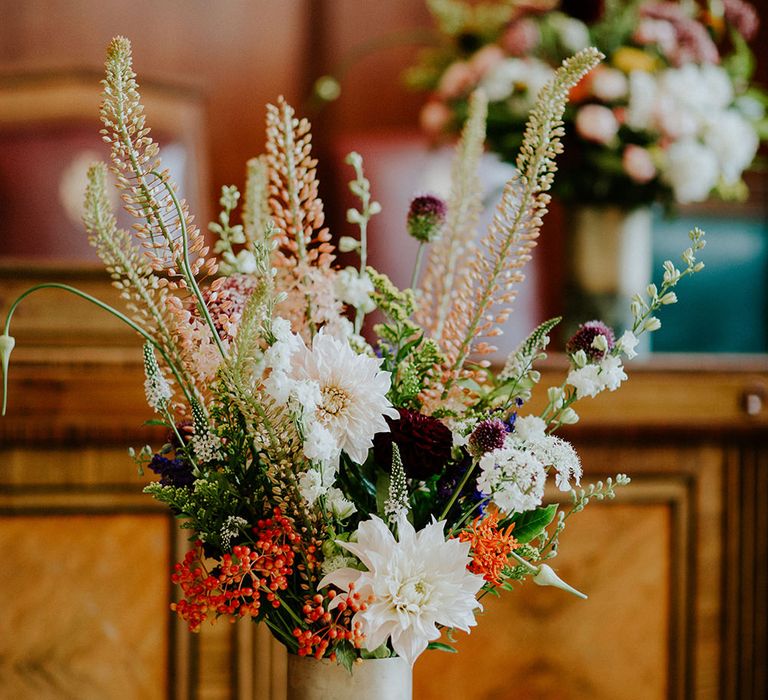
[288,654,413,700]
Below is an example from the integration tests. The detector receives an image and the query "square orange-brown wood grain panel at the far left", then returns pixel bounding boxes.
[0,515,169,700]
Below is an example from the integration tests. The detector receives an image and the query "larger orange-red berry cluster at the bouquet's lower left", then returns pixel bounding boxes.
[171,509,298,632]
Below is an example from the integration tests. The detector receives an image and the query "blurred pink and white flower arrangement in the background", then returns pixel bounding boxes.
[409,0,768,206]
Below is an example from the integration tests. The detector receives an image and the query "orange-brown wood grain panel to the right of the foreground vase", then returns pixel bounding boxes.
[414,504,672,700]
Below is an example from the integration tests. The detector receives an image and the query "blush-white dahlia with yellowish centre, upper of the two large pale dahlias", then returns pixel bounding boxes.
[289,332,399,464]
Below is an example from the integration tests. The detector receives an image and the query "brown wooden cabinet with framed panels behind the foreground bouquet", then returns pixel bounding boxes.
[0,274,768,700]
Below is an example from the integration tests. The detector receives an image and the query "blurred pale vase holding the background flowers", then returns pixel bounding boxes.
[566,206,653,342]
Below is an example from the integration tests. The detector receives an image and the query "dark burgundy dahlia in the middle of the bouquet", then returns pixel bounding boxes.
[373,408,453,479]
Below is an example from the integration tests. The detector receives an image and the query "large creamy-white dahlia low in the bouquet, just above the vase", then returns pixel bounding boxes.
[319,515,484,665]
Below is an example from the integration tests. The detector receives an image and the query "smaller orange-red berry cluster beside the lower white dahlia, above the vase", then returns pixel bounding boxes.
[293,583,368,661]
